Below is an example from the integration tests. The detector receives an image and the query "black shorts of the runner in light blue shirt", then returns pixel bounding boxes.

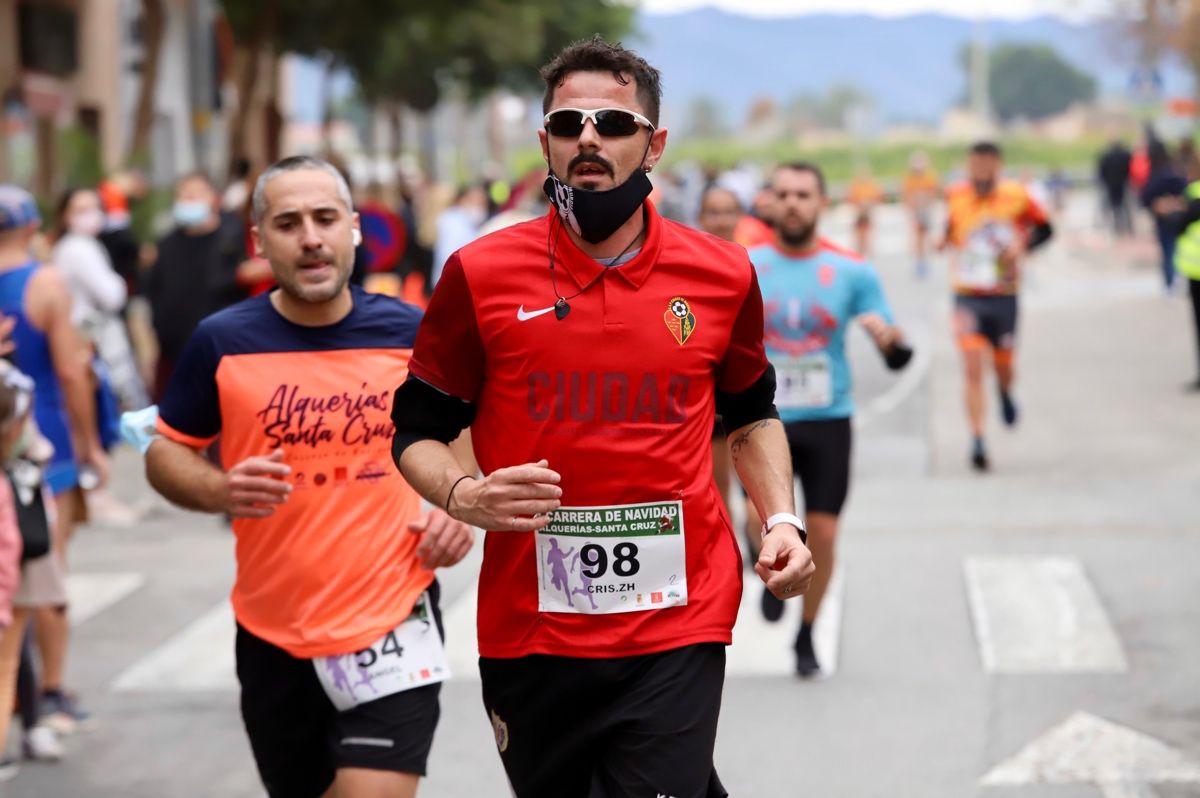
[784,418,851,515]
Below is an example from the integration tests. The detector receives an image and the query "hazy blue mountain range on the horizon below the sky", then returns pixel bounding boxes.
[626,8,1192,125]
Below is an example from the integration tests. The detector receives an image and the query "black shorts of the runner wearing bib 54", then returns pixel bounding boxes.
[236,582,445,798]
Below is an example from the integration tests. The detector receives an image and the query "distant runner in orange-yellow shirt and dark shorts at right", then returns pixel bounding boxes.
[938,142,1054,472]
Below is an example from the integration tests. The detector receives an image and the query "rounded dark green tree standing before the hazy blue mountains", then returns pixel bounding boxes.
[962,43,1096,121]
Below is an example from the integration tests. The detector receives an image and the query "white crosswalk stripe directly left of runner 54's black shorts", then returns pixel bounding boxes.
[113,600,238,692]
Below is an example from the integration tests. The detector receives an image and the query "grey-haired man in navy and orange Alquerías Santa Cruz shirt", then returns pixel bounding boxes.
[146,157,473,798]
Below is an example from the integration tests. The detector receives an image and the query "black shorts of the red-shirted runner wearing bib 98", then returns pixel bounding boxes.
[479,643,728,798]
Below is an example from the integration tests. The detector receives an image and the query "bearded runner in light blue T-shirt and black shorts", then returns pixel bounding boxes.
[746,162,912,678]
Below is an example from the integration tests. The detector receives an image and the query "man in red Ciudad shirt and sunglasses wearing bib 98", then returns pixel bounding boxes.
[392,38,812,798]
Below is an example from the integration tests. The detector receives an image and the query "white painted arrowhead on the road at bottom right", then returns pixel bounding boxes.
[979,712,1200,798]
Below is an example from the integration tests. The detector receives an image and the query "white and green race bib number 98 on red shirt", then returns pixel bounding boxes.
[536,502,688,614]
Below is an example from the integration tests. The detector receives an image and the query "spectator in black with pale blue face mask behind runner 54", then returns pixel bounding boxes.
[145,173,247,400]
